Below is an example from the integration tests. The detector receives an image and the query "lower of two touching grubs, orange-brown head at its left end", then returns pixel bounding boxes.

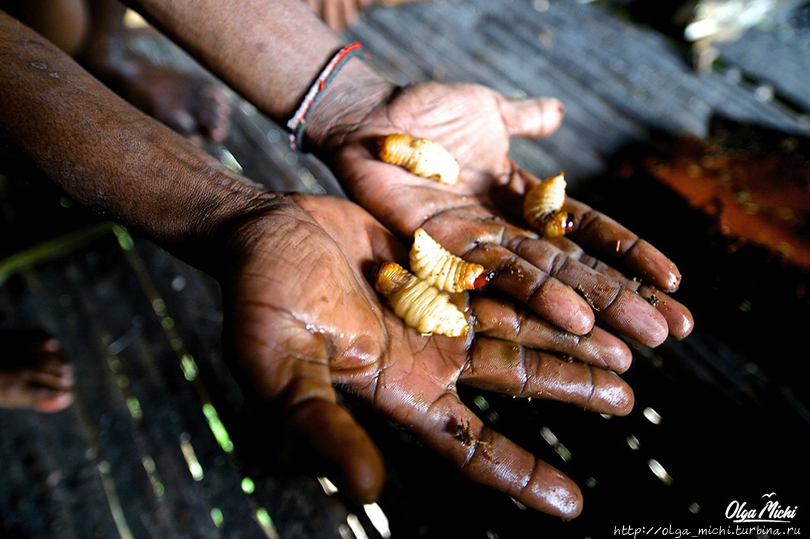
[376,262,470,337]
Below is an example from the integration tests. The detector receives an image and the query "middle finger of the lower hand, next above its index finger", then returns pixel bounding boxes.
[459,337,635,415]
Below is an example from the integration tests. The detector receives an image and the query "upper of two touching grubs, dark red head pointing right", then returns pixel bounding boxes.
[410,228,491,292]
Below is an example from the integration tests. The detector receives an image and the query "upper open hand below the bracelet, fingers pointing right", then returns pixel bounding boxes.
[321,83,693,346]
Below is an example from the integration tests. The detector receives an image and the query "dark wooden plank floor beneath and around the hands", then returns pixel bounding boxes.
[0,0,810,538]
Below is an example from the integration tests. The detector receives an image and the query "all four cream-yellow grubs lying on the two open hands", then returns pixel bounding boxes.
[376,134,574,337]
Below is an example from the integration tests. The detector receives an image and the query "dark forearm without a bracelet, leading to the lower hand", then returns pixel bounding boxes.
[0,12,280,269]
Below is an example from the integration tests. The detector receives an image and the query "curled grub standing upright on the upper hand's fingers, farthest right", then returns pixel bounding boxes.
[523,173,574,237]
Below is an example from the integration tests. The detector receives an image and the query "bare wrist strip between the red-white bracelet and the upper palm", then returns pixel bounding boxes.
[304,58,396,156]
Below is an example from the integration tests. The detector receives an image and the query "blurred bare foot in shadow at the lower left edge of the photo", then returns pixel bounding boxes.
[0,330,74,413]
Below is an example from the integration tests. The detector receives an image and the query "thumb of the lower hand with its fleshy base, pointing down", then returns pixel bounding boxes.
[225,292,385,502]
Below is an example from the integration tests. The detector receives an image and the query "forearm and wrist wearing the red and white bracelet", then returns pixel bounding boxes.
[120,0,393,151]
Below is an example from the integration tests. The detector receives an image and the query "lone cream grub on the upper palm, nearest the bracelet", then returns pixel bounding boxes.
[380,134,459,185]
